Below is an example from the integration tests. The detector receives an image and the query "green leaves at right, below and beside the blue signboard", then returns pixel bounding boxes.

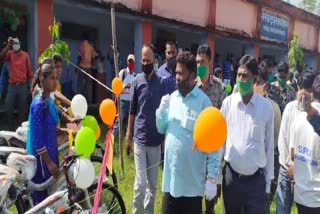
[288,33,304,72]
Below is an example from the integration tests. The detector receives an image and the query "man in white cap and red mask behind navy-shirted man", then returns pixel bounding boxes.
[113,54,136,136]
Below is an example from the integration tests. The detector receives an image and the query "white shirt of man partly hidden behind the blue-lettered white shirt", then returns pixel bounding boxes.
[278,100,301,169]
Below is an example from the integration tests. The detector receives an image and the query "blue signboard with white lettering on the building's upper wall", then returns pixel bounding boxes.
[260,11,289,42]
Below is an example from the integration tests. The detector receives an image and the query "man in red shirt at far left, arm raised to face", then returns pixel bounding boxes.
[0,38,32,131]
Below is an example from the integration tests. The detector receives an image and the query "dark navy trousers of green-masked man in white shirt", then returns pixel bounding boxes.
[222,163,267,214]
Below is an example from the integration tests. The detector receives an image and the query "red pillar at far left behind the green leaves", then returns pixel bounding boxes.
[37,0,53,60]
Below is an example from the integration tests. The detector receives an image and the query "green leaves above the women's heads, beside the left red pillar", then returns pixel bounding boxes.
[38,19,70,63]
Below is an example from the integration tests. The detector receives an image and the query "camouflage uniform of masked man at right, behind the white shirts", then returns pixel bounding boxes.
[268,81,296,114]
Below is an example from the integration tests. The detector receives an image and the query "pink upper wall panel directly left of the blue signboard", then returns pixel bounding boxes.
[216,0,257,36]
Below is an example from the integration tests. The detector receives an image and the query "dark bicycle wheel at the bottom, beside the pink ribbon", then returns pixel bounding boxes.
[82,183,126,214]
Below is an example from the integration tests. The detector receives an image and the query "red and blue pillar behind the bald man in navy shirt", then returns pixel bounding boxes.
[134,20,152,73]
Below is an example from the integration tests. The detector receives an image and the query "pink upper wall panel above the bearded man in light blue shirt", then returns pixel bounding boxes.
[152,0,209,26]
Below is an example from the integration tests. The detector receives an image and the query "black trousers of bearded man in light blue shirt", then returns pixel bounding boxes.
[162,193,202,214]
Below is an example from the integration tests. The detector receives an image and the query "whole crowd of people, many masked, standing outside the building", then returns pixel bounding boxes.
[0,35,320,214]
